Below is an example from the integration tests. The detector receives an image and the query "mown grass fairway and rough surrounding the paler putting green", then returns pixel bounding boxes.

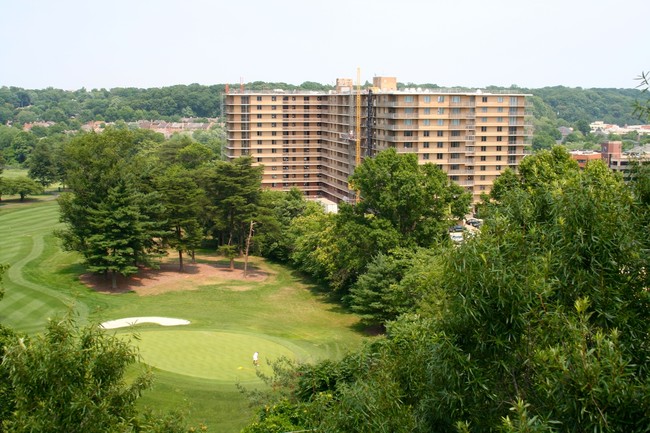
[0,197,370,432]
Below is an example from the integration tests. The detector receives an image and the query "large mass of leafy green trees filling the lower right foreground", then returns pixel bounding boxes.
[239,148,650,432]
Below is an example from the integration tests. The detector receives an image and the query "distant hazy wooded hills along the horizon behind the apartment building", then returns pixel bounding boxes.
[0,81,642,166]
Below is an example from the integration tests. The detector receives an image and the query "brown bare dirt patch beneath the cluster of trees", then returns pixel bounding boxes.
[80,263,269,296]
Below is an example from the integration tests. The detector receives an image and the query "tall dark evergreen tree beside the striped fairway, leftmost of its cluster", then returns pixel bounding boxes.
[59,129,166,286]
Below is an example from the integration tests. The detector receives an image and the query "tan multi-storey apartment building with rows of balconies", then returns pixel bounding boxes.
[225,77,532,202]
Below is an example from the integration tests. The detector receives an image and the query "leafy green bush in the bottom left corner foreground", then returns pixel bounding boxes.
[0,319,186,433]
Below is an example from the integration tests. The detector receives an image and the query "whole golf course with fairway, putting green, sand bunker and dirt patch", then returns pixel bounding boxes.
[0,185,367,432]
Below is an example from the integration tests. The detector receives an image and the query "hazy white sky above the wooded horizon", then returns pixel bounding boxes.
[0,0,650,90]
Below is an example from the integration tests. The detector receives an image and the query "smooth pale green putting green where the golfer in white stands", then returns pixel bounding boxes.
[126,330,306,382]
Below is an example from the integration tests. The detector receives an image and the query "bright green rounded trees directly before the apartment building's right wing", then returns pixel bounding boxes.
[289,149,471,296]
